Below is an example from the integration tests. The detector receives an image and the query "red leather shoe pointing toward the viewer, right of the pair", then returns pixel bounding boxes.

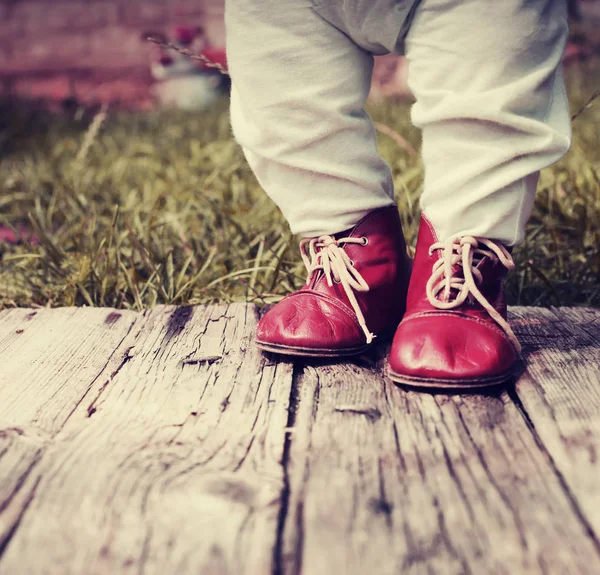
[388,216,521,389]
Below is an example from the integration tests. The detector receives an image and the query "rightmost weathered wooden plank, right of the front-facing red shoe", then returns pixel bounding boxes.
[512,308,600,540]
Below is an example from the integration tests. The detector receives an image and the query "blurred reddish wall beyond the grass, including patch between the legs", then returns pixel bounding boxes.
[0,0,600,108]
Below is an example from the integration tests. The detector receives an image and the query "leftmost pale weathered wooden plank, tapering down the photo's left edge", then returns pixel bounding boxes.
[0,308,135,552]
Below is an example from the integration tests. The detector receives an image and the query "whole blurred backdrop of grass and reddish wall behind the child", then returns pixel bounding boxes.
[0,0,600,309]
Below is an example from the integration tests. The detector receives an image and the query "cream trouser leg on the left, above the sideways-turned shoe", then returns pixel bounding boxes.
[225,0,393,237]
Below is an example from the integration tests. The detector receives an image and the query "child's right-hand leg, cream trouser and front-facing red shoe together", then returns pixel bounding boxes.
[390,0,570,388]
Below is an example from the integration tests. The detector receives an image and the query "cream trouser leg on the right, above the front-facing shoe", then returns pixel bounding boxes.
[406,0,571,245]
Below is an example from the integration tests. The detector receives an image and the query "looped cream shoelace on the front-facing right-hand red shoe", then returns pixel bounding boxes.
[426,236,521,353]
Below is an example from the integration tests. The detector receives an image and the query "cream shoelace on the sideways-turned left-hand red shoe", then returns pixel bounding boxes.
[300,236,375,343]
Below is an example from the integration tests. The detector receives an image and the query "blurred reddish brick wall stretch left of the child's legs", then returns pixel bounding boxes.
[0,0,225,105]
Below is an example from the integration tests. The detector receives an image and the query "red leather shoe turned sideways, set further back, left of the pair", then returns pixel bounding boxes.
[256,206,410,357]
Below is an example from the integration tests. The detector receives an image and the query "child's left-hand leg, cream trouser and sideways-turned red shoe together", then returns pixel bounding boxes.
[225,0,412,357]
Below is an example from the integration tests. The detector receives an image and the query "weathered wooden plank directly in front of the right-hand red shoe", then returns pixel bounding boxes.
[283,348,600,575]
